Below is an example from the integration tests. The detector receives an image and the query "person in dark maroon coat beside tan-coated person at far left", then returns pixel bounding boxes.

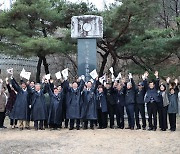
[6,78,17,129]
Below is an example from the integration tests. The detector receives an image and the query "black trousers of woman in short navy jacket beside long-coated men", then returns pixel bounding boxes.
[98,109,107,128]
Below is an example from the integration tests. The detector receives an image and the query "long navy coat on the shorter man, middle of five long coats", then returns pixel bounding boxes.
[48,84,64,125]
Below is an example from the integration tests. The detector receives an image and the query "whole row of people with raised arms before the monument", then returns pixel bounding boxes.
[0,71,179,131]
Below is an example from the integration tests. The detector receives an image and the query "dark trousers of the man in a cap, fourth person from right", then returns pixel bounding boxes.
[135,104,146,129]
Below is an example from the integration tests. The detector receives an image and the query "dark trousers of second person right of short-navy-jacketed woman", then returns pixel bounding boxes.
[116,104,124,129]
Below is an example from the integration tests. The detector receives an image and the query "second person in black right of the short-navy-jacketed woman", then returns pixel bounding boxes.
[115,83,125,129]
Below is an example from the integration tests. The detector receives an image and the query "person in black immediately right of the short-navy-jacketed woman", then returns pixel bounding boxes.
[104,82,116,129]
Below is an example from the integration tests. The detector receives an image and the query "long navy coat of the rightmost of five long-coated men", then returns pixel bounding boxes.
[81,81,97,120]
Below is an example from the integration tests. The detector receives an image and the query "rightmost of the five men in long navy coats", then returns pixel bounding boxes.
[81,79,98,129]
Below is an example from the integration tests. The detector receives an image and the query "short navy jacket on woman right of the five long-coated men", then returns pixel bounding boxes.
[96,92,107,112]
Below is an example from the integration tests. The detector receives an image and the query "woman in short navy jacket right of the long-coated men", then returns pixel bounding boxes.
[96,85,107,129]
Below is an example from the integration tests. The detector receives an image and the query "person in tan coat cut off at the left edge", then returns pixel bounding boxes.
[0,79,7,128]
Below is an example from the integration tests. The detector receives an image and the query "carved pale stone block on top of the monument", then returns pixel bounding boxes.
[71,15,103,38]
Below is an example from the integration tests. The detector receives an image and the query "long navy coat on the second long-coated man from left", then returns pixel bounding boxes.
[29,87,47,121]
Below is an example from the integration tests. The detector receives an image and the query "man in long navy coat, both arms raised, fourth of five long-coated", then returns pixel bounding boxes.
[63,79,85,130]
